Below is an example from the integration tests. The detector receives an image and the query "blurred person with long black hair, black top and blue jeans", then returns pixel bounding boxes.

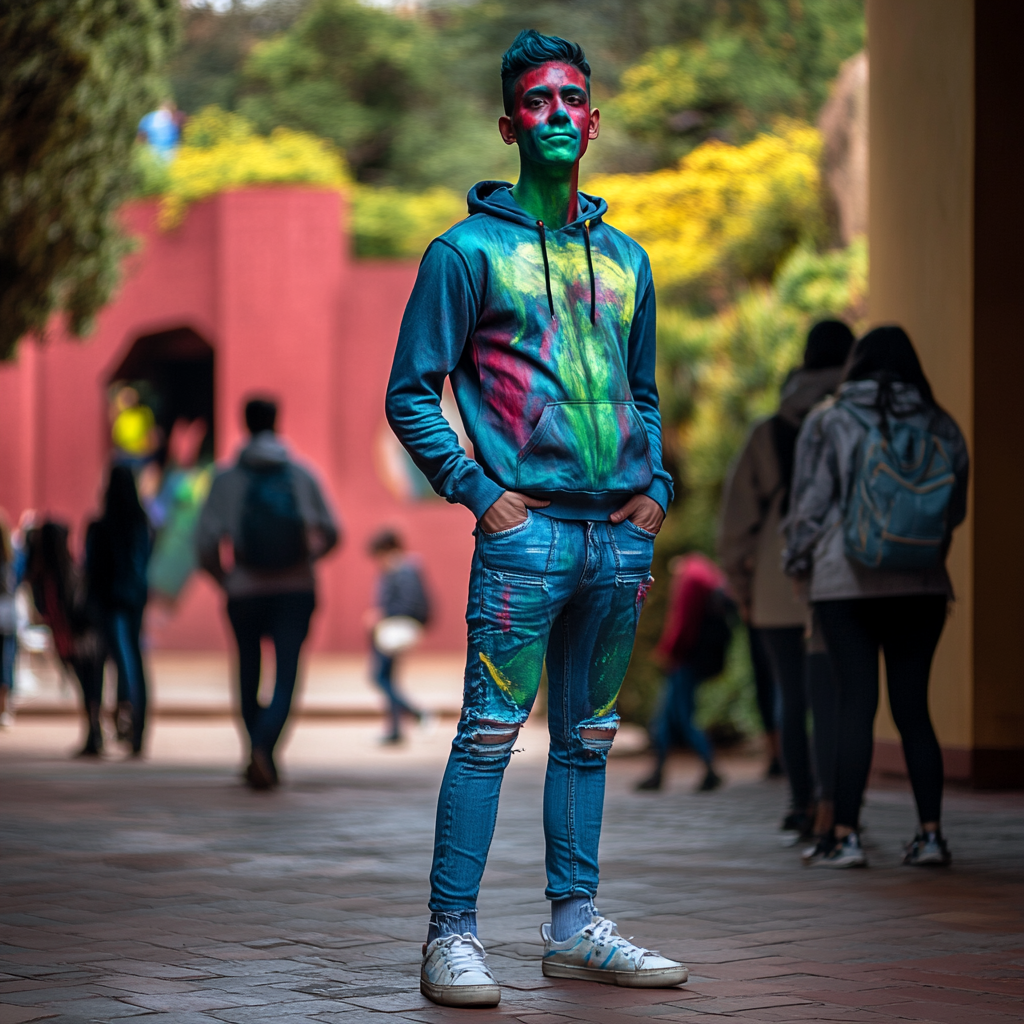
[85,465,153,757]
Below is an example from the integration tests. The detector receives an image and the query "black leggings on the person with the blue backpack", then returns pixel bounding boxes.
[814,594,946,828]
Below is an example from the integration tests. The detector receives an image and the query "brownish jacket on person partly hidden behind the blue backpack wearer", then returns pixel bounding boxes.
[718,367,843,628]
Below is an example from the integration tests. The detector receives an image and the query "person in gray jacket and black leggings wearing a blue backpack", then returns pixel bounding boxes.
[785,327,968,867]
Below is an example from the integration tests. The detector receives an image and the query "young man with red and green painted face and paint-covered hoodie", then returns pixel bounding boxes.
[387,31,687,1006]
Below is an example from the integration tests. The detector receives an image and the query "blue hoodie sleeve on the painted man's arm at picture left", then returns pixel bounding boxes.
[385,239,504,519]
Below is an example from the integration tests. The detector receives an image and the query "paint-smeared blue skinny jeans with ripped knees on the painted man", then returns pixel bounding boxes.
[430,512,654,921]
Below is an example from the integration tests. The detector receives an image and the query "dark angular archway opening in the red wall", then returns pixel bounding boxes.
[109,327,216,460]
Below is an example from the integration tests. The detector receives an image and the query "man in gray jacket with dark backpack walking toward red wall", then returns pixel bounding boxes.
[196,398,338,790]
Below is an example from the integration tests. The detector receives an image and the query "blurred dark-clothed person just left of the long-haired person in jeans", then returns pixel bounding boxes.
[25,520,106,757]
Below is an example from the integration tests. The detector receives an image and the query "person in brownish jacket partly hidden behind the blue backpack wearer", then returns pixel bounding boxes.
[718,319,853,842]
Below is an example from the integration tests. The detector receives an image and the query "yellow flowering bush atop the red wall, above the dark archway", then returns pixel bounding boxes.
[160,106,348,229]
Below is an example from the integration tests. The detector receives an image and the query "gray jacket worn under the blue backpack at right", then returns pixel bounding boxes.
[784,380,969,601]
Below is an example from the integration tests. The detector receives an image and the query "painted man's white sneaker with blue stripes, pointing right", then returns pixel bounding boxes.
[541,916,690,988]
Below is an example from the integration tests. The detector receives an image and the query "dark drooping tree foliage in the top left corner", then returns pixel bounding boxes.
[0,0,178,357]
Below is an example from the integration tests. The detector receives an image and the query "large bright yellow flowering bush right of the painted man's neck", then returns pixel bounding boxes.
[587,121,821,298]
